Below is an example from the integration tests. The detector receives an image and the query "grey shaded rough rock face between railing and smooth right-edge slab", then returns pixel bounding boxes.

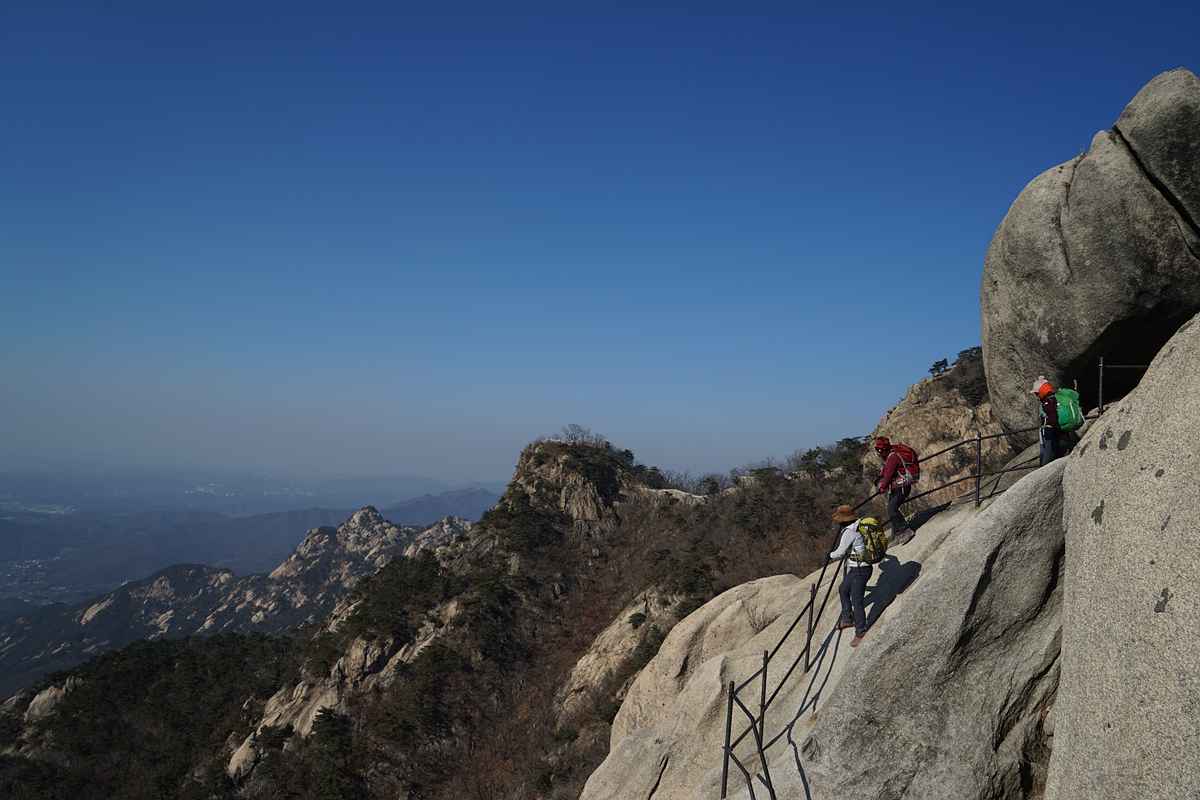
[800,461,1064,800]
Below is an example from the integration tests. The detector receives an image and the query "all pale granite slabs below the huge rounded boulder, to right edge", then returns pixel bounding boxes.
[582,302,1200,800]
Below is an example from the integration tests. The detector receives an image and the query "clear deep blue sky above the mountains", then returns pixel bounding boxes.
[0,0,1200,482]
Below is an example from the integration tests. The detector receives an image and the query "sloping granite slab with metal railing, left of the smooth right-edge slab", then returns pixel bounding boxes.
[582,462,1066,800]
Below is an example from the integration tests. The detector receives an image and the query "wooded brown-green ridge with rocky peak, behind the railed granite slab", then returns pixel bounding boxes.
[0,429,866,798]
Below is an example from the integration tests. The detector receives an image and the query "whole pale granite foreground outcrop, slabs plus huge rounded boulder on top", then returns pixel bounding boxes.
[582,70,1200,800]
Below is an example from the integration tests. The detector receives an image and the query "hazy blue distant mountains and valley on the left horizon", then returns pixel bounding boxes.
[0,469,499,604]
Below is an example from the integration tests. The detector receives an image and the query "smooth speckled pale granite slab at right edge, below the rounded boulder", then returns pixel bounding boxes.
[1045,318,1200,800]
